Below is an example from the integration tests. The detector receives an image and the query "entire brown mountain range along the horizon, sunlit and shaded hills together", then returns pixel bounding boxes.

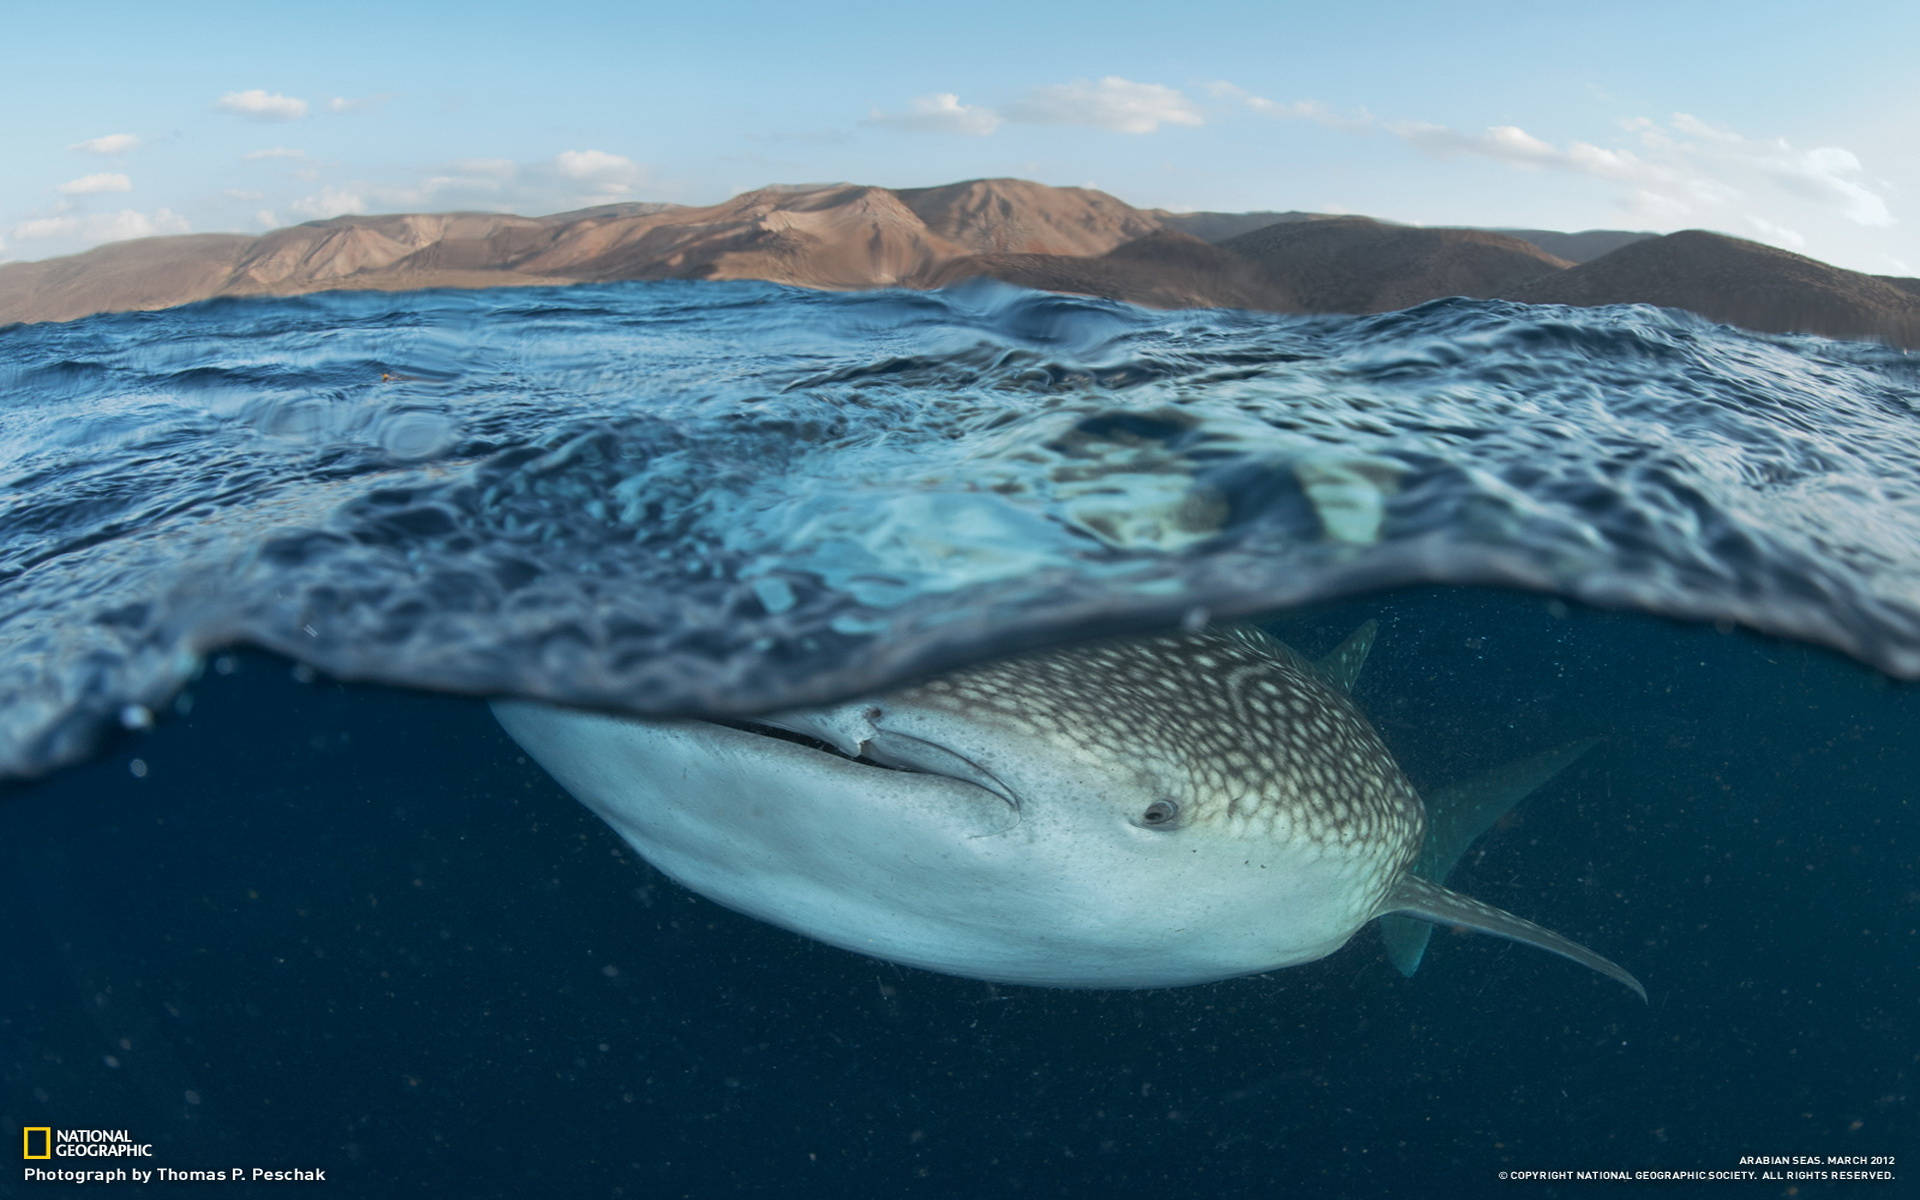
[0,179,1920,348]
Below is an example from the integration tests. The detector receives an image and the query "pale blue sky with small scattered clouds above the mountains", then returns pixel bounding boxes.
[0,0,1920,275]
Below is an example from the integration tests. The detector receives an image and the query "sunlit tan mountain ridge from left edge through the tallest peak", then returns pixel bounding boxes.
[0,179,1160,321]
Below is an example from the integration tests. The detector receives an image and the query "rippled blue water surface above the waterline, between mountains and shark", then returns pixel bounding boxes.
[0,282,1920,774]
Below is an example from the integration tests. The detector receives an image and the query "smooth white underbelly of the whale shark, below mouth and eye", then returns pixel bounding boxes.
[493,701,1367,987]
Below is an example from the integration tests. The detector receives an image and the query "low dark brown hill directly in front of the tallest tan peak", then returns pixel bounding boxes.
[914,230,1304,313]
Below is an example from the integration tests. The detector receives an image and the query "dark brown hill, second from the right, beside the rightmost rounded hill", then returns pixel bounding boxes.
[1221,217,1569,313]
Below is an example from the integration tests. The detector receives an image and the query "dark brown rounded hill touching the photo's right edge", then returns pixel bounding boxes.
[1505,228,1920,346]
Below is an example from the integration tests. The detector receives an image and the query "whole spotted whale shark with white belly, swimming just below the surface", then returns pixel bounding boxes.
[493,622,1645,1000]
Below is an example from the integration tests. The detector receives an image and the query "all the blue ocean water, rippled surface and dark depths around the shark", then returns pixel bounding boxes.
[0,282,1920,1196]
